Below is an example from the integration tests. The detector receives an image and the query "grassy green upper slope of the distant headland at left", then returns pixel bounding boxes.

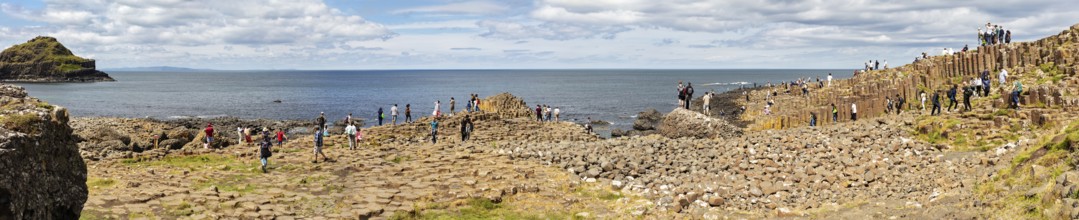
[0,37,90,64]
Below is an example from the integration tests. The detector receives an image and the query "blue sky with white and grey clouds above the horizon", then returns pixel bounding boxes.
[0,0,1079,70]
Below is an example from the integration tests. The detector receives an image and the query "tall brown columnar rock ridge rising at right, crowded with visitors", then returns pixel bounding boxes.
[737,25,1079,129]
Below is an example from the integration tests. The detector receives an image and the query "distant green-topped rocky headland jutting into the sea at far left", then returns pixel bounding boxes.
[0,37,114,82]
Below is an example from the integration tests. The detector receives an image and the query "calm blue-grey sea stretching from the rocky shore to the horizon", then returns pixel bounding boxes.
[12,70,851,127]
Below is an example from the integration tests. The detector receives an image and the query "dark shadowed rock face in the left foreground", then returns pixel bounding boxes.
[0,84,87,219]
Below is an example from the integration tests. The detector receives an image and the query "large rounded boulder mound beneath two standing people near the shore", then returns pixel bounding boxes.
[658,109,741,138]
